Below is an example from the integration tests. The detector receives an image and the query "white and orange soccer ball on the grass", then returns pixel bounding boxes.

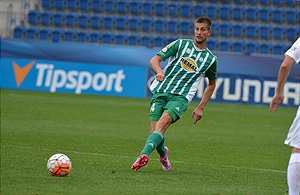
[47,154,72,177]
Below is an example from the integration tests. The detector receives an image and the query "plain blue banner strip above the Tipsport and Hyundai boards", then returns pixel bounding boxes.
[1,39,300,78]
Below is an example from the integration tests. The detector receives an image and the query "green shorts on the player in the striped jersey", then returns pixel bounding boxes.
[150,93,189,122]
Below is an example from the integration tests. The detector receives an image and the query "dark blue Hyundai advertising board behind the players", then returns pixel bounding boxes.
[147,65,300,107]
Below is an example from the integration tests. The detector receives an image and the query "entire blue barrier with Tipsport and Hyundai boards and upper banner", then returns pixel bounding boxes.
[1,39,300,107]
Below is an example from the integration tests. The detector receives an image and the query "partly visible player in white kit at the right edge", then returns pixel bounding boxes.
[270,37,300,195]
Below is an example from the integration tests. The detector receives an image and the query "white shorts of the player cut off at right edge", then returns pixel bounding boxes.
[284,106,300,149]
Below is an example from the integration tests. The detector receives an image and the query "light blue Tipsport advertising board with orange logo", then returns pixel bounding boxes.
[1,58,147,98]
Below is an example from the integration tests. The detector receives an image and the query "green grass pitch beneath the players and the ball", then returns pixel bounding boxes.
[0,89,296,195]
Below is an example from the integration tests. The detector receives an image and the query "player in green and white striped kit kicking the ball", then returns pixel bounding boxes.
[131,17,218,171]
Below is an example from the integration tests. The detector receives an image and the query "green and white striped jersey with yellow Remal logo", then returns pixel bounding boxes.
[150,39,218,102]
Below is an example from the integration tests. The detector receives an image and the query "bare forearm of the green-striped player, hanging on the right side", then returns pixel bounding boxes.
[192,80,216,124]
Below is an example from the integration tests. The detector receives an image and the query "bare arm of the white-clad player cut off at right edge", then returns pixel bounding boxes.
[270,55,296,112]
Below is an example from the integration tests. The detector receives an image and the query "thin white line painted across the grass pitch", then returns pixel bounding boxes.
[1,145,287,174]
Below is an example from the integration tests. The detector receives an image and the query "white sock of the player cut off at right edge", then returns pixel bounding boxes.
[287,153,300,195]
